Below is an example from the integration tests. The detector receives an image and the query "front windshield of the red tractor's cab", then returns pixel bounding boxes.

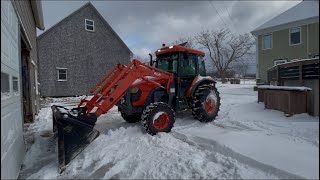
[157,53,178,73]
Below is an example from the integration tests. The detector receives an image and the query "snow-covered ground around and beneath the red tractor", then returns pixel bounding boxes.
[19,81,319,179]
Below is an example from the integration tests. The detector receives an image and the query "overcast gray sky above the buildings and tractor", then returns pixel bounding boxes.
[38,1,301,72]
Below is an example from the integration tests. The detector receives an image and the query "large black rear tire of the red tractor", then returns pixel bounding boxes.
[190,84,220,122]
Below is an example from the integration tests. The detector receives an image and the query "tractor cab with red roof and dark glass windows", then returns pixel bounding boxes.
[154,45,206,97]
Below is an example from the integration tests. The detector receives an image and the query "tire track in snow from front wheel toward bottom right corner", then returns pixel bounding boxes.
[171,132,305,179]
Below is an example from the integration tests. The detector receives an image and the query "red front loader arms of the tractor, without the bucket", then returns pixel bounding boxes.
[78,59,174,117]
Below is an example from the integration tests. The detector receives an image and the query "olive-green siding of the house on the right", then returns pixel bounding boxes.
[258,23,319,82]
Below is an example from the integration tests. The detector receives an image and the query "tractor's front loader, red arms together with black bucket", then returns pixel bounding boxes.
[51,59,174,173]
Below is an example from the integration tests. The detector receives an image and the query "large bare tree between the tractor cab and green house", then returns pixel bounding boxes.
[195,29,254,80]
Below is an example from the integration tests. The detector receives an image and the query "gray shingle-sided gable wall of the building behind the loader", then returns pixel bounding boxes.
[38,3,131,97]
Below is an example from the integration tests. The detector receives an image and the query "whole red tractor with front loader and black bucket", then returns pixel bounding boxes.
[52,45,220,172]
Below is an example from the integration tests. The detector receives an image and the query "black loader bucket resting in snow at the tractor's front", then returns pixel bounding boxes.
[51,105,100,173]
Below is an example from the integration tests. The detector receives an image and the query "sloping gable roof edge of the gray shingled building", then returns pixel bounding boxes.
[37,2,133,54]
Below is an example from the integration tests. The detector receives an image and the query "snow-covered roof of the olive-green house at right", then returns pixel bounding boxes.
[252,1,319,32]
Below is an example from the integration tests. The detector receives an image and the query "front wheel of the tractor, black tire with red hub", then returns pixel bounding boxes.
[141,102,175,135]
